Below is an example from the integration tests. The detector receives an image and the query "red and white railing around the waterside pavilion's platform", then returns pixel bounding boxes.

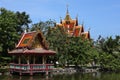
[10,63,54,72]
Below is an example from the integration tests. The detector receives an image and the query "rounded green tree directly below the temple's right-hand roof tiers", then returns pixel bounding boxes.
[68,37,94,66]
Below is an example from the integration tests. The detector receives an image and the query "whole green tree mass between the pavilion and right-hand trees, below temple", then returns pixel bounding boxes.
[47,27,95,66]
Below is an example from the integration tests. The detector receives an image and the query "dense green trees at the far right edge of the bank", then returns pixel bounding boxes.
[96,36,120,71]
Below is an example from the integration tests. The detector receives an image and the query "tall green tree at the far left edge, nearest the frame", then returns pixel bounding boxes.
[0,8,18,54]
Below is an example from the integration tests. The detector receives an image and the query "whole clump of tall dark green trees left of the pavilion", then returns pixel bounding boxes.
[0,8,31,63]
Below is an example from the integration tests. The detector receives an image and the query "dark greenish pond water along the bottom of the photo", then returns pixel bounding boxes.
[0,72,120,80]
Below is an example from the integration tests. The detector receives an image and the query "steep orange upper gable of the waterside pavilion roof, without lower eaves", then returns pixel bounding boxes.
[16,31,47,49]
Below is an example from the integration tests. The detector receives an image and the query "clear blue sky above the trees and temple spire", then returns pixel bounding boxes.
[0,0,120,39]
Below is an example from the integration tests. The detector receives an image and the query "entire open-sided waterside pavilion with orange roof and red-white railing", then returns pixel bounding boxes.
[9,31,56,75]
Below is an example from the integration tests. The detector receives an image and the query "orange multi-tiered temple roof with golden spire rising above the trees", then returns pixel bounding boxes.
[57,8,90,39]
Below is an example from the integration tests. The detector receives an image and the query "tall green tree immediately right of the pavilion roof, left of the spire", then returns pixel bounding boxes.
[46,27,68,66]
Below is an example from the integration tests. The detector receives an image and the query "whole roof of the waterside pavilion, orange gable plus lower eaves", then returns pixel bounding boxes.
[9,31,56,55]
